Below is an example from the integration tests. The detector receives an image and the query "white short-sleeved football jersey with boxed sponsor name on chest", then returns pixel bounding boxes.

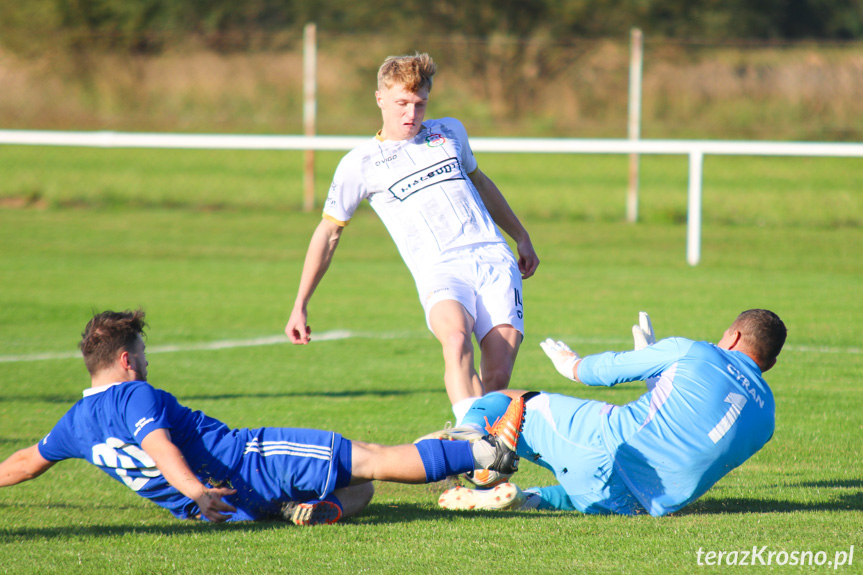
[323,118,505,278]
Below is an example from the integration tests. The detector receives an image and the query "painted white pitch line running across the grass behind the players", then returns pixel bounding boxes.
[0,330,863,363]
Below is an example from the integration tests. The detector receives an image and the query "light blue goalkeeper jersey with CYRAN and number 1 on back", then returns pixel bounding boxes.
[578,337,775,515]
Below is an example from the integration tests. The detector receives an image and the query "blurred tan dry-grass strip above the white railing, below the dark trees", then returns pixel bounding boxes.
[0,35,863,141]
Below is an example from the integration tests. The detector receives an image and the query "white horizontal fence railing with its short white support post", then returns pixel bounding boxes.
[0,130,863,266]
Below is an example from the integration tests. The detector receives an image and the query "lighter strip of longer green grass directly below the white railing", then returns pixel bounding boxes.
[5,146,863,228]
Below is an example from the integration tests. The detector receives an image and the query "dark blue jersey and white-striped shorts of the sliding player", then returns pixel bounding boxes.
[39,381,350,521]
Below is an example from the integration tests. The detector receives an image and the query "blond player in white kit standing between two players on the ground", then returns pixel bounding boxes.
[285,54,539,420]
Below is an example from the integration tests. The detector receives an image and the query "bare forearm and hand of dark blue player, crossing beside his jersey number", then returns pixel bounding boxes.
[141,429,237,523]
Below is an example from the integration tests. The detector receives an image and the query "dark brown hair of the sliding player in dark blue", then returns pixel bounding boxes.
[78,308,147,375]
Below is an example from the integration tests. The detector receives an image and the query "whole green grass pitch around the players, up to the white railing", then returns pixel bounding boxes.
[0,148,863,574]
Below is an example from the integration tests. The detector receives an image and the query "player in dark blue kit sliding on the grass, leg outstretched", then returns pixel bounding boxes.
[0,310,521,525]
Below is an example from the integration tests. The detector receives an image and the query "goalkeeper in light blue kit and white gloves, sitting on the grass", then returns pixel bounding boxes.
[438,309,786,516]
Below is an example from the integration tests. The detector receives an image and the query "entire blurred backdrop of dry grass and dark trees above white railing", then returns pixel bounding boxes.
[0,0,863,141]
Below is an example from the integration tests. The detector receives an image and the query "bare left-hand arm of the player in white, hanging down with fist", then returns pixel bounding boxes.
[285,218,344,344]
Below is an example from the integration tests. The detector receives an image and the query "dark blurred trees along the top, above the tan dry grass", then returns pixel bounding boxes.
[0,0,863,54]
